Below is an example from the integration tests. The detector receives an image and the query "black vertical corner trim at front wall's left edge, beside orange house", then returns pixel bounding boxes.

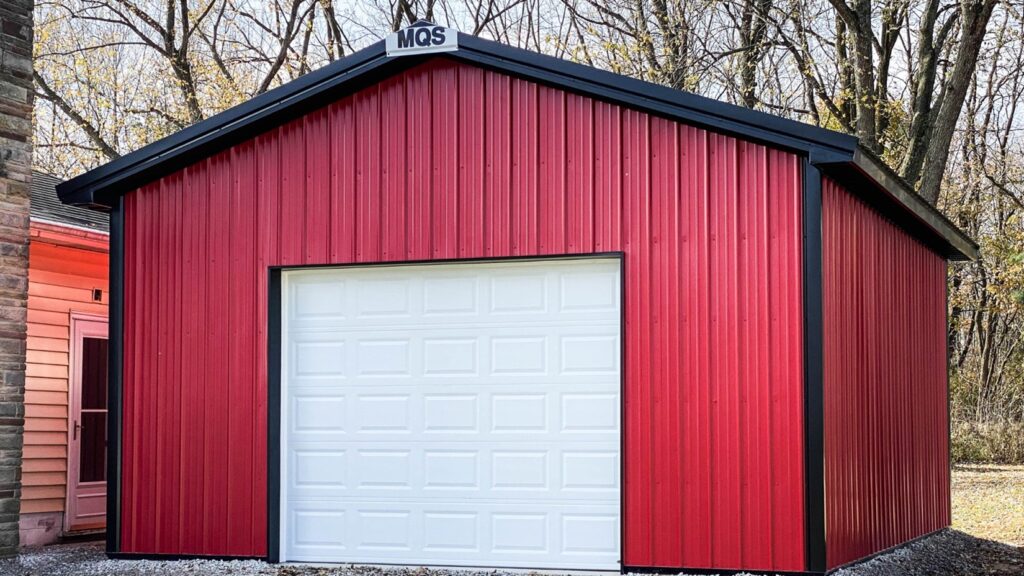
[106,197,125,556]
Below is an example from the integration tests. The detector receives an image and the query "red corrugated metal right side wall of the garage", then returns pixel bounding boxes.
[821,174,949,568]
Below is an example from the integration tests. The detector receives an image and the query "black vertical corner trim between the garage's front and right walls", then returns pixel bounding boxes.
[803,159,826,574]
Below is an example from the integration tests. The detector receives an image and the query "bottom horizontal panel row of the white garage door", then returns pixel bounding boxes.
[289,500,618,568]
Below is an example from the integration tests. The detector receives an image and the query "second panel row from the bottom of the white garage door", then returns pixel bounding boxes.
[288,441,621,501]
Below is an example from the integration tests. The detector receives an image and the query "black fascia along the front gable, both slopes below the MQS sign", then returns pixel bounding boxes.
[57,33,857,209]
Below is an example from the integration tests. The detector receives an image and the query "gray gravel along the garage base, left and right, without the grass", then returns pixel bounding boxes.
[0,530,1024,576]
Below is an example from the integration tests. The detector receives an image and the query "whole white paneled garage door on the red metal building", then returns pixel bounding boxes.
[281,259,621,570]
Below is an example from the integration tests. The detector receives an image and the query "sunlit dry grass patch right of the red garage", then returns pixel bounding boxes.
[952,464,1024,546]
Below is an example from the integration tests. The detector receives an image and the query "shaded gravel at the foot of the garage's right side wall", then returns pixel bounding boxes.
[835,530,1024,576]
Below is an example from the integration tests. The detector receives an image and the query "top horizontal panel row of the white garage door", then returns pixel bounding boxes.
[289,260,621,332]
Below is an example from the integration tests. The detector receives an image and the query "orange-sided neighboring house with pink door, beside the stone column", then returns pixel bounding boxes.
[20,172,110,545]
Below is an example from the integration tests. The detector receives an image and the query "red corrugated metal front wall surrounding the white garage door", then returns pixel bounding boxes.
[122,59,804,570]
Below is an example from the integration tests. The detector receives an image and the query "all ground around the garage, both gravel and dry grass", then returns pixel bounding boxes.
[0,466,1024,576]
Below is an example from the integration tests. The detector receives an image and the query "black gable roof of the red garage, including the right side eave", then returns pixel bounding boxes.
[57,23,978,259]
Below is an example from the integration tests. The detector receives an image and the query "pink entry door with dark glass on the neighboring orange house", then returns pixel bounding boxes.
[65,315,106,532]
